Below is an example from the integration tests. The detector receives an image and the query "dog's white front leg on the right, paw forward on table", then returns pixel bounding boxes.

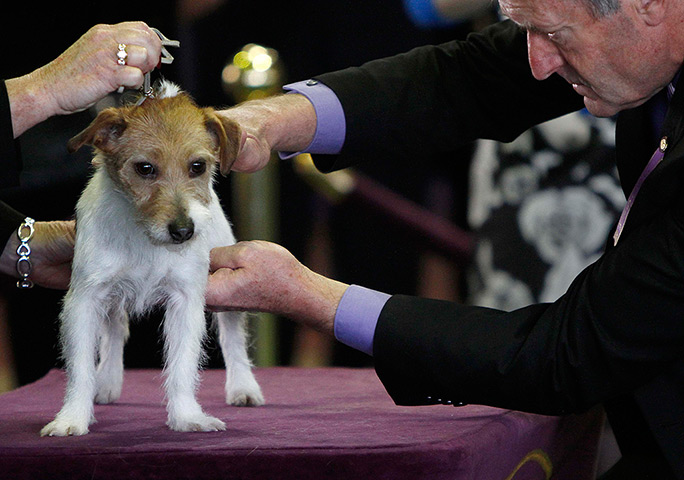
[164,292,226,432]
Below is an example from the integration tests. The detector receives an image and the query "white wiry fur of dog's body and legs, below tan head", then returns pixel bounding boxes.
[41,145,263,436]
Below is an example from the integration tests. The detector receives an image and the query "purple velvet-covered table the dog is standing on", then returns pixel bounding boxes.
[0,368,601,480]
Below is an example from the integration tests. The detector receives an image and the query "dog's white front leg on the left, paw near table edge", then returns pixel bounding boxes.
[40,290,104,436]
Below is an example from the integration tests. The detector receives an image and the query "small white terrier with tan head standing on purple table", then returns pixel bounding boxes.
[41,81,264,436]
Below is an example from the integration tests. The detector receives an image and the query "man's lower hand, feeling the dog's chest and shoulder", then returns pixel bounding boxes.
[207,241,348,335]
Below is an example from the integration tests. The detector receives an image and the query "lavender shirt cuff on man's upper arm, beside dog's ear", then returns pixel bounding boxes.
[278,80,347,160]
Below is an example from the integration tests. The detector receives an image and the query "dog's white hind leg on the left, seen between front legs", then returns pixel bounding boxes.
[95,305,129,403]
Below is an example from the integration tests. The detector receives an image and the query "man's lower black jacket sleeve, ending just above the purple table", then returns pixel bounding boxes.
[374,191,684,414]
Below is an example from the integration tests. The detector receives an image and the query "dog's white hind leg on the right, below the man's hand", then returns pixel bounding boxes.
[214,312,264,406]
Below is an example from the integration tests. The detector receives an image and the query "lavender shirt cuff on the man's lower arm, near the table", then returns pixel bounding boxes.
[334,285,390,356]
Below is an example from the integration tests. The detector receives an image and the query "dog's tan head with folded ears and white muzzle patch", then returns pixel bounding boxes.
[67,84,240,244]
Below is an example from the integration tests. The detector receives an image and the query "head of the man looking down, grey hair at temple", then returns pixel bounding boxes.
[500,0,684,116]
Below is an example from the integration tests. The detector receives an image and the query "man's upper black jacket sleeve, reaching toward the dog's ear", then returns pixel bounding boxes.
[314,21,583,171]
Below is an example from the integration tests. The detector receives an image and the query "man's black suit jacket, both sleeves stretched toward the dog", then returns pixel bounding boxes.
[316,22,684,478]
